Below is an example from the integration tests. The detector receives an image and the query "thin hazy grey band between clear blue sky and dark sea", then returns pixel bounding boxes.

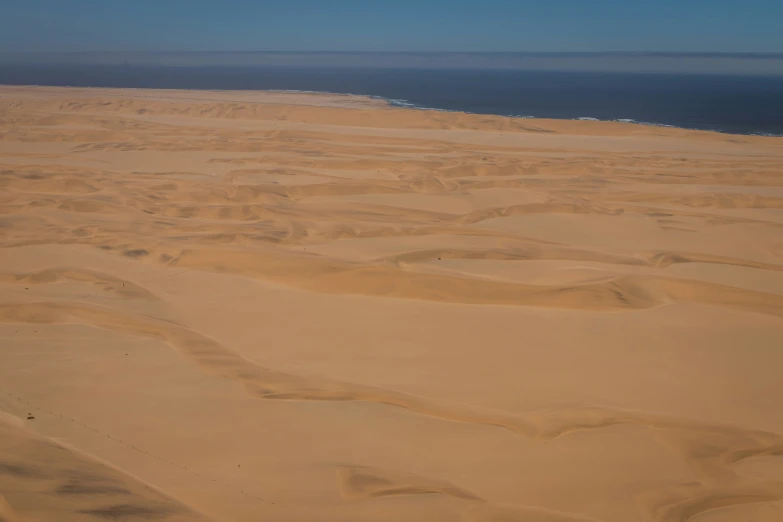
[0,51,783,76]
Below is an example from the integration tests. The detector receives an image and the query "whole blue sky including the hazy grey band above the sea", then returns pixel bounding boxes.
[0,0,783,76]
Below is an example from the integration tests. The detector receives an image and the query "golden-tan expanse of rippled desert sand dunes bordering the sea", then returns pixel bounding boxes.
[0,87,783,522]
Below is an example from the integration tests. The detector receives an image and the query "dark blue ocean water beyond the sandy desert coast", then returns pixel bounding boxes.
[0,65,783,136]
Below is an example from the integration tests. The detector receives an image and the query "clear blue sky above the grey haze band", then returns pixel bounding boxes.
[0,0,783,53]
